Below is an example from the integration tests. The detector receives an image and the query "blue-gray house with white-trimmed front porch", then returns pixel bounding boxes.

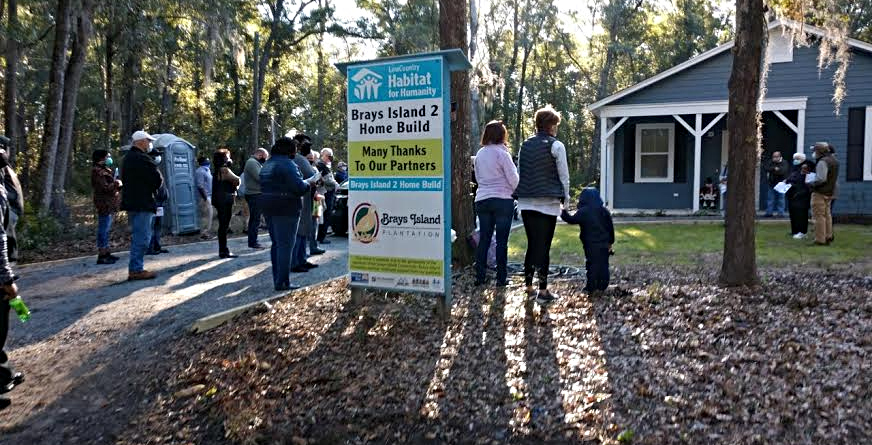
[589,21,872,215]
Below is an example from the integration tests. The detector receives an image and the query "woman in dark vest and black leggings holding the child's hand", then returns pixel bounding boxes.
[515,106,569,304]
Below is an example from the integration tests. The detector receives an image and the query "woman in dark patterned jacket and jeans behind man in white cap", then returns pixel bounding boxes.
[91,150,121,264]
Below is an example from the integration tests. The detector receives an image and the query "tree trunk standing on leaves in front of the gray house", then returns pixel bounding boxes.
[719,0,767,286]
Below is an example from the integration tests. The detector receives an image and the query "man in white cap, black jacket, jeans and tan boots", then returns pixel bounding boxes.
[121,130,163,280]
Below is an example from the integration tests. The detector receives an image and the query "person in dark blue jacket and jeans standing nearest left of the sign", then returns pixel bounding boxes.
[258,137,320,290]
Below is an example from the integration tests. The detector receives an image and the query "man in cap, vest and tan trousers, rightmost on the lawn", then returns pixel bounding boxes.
[809,142,839,246]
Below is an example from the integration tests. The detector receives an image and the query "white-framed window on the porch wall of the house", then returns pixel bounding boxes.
[636,124,675,182]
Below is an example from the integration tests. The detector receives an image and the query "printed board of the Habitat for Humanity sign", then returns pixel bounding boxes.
[348,57,448,292]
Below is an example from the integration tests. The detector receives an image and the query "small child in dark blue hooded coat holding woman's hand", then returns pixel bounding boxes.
[560,187,615,292]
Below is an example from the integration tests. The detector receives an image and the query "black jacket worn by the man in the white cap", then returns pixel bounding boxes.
[121,147,163,212]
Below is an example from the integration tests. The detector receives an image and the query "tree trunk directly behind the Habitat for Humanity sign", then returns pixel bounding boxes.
[439,0,475,267]
